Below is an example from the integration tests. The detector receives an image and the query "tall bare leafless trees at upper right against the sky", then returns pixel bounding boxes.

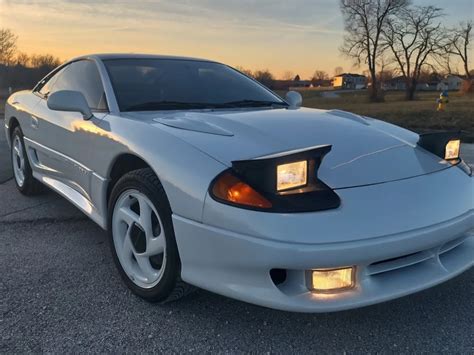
[340,0,473,101]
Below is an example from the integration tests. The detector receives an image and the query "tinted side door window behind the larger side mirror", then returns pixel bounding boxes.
[51,60,107,110]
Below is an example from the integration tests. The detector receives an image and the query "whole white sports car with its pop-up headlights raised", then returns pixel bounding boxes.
[5,54,474,312]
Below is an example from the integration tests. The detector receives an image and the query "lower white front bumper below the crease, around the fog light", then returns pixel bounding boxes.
[173,213,474,312]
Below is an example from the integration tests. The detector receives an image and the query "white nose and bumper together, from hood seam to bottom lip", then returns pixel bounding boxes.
[173,169,474,312]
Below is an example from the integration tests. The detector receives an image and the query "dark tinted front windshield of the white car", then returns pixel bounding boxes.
[104,59,288,111]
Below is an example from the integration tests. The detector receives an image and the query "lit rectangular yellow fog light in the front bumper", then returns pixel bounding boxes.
[311,267,355,293]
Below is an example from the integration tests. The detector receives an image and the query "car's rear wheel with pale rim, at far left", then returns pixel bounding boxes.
[11,127,43,196]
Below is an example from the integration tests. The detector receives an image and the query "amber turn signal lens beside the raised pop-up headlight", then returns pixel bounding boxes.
[212,173,272,208]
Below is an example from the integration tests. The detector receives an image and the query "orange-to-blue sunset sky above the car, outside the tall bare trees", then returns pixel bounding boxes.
[0,0,474,77]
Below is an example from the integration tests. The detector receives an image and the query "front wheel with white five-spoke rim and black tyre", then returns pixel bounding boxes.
[109,169,192,302]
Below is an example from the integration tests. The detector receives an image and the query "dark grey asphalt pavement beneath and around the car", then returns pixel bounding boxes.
[0,120,474,353]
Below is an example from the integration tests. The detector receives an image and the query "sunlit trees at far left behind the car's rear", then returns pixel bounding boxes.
[0,28,61,89]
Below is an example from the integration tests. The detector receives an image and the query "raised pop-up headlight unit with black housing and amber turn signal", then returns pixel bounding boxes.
[209,145,341,213]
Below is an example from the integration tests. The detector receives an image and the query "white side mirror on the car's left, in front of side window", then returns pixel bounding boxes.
[47,90,94,120]
